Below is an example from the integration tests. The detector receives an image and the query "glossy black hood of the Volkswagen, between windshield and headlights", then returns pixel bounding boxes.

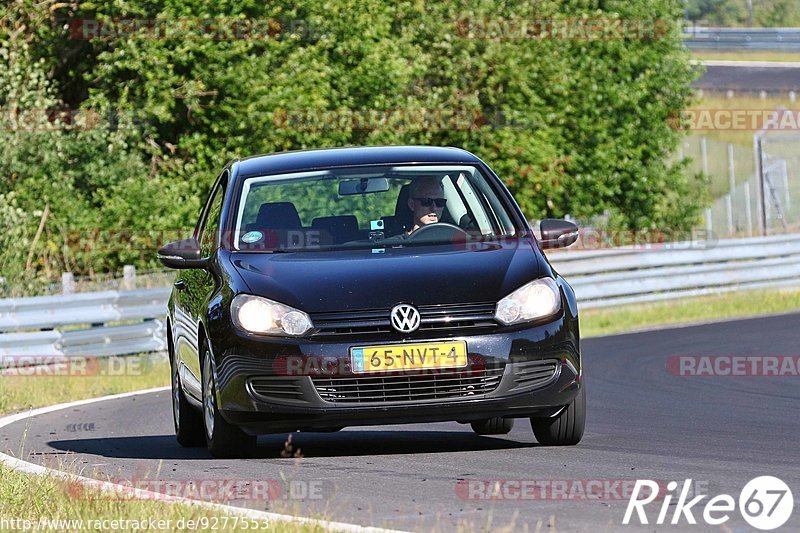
[230,240,543,313]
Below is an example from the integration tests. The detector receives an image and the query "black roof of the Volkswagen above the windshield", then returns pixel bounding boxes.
[234,146,481,178]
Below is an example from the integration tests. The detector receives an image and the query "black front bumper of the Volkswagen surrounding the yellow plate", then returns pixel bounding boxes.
[209,316,582,434]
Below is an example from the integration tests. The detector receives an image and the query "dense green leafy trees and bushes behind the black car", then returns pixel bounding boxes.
[0,0,701,290]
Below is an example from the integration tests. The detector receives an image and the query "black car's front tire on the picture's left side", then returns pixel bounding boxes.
[202,346,256,459]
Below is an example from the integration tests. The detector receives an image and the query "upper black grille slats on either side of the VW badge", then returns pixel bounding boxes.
[311,302,497,336]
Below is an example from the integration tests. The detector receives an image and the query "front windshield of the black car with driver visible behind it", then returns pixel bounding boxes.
[234,165,519,252]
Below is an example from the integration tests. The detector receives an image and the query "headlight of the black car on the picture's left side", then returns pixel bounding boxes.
[231,294,312,337]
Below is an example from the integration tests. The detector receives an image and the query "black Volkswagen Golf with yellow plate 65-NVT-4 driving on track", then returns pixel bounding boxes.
[159,146,586,457]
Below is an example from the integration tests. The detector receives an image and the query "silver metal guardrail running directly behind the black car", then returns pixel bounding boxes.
[0,235,800,366]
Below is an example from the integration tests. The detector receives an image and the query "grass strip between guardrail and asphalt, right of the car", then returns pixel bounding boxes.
[580,289,800,337]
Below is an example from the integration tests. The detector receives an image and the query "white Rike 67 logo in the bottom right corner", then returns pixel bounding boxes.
[622,476,794,531]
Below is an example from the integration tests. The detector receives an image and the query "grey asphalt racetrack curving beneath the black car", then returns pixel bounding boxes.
[0,314,800,532]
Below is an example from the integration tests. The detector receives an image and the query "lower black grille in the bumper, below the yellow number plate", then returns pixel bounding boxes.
[312,366,504,403]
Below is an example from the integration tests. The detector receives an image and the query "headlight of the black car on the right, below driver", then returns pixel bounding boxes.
[494,278,561,326]
